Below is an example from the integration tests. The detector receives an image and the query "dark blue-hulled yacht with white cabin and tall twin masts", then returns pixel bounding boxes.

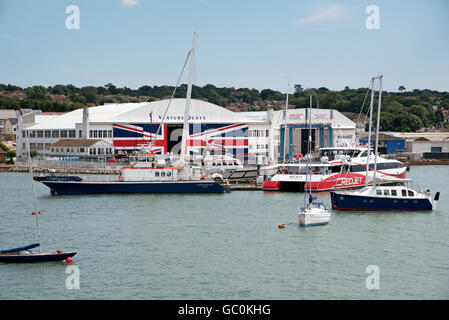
[331,75,440,211]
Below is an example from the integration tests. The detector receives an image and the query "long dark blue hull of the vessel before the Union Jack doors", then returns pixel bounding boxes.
[41,180,227,194]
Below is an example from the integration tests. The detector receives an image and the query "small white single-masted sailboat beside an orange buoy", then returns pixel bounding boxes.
[298,96,331,227]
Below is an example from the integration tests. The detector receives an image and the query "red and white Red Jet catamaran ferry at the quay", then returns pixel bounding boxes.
[263,146,407,191]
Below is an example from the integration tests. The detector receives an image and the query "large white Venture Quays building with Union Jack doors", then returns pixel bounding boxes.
[17,99,355,164]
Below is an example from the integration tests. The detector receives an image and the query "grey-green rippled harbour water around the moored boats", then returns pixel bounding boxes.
[0,166,449,300]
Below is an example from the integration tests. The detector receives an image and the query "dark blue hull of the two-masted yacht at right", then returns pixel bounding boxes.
[331,191,432,211]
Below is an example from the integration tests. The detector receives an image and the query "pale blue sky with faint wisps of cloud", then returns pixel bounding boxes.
[0,0,449,92]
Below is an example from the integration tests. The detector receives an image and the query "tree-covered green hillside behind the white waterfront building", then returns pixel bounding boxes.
[0,83,449,132]
